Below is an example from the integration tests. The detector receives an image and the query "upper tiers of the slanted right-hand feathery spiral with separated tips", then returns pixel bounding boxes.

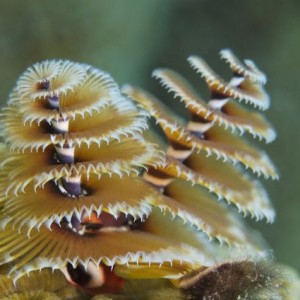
[123,49,278,222]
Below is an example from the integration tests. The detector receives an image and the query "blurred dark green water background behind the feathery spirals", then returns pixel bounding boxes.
[0,0,300,270]
